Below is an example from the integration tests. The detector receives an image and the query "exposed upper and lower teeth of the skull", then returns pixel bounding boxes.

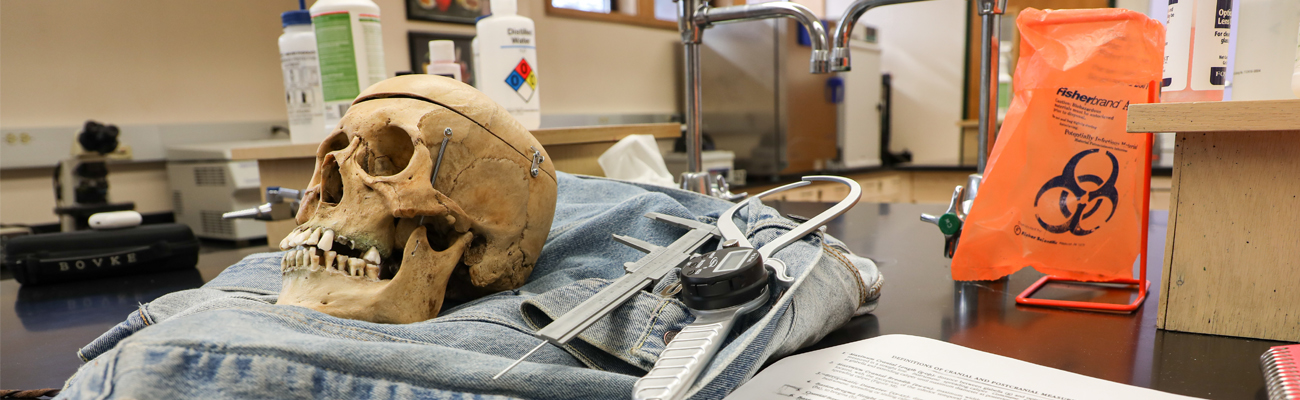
[280,227,384,281]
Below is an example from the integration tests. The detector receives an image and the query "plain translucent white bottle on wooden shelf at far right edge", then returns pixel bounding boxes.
[1232,0,1300,100]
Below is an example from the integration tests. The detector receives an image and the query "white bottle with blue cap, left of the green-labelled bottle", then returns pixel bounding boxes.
[280,9,329,143]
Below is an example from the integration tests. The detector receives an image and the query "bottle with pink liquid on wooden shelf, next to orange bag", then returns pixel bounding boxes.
[1161,0,1232,103]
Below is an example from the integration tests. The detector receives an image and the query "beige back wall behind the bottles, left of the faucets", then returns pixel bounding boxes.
[0,0,679,223]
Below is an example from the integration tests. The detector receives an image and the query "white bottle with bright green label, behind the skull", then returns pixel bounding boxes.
[312,0,387,130]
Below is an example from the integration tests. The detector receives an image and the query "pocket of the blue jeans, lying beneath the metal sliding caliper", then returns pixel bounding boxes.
[521,278,694,377]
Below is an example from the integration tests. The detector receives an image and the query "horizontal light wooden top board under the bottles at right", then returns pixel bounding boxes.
[1128,100,1300,132]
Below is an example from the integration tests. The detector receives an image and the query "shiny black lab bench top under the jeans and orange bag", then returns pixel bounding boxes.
[0,201,1283,399]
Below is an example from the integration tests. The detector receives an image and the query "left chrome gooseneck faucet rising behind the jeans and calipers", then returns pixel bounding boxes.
[676,0,831,200]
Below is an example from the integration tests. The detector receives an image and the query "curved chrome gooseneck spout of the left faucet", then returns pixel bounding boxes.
[694,0,832,74]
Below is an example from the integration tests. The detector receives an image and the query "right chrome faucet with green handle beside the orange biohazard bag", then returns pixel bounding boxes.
[831,0,1006,258]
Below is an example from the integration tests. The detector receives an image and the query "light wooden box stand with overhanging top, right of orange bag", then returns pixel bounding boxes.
[1128,100,1300,342]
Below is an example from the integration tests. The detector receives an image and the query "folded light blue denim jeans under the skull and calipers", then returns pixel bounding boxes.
[60,173,883,399]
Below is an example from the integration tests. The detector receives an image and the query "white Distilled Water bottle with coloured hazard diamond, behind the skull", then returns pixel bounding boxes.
[475,0,542,130]
